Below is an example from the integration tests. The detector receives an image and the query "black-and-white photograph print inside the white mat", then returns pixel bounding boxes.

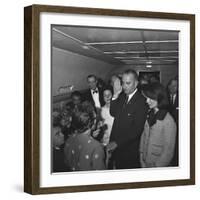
[50,24,181,173]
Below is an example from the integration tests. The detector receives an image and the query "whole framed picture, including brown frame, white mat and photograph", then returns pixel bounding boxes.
[24,5,195,194]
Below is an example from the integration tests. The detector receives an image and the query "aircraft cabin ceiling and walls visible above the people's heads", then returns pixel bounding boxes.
[51,25,179,104]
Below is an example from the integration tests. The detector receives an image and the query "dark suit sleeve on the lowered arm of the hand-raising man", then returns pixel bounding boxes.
[116,99,147,146]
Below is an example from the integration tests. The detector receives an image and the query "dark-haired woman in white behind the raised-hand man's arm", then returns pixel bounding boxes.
[101,87,114,146]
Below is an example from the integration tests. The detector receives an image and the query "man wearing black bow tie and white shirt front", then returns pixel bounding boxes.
[84,74,104,108]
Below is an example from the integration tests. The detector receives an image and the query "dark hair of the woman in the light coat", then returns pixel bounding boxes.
[142,83,169,109]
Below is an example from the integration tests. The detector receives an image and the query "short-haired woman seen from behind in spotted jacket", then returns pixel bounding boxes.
[64,104,106,171]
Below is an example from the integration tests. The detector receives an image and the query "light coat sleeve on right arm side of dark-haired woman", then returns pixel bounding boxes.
[155,119,176,167]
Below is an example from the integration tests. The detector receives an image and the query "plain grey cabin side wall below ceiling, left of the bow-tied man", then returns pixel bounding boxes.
[52,48,115,95]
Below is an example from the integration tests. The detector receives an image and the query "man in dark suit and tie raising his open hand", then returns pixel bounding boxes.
[107,70,147,169]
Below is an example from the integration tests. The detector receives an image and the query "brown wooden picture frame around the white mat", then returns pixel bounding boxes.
[24,5,195,194]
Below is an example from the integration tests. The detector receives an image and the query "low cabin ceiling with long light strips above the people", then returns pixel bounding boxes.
[52,25,178,65]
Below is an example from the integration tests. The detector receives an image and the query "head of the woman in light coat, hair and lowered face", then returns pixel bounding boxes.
[142,83,168,109]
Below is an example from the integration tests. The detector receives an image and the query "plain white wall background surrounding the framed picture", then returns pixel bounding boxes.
[0,0,200,200]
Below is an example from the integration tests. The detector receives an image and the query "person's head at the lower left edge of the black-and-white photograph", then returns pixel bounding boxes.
[52,126,65,147]
